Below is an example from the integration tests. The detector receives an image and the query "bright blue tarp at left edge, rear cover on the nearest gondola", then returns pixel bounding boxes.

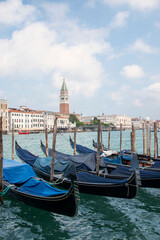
[3,159,37,184]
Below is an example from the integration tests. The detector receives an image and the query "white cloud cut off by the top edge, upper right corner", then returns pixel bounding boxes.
[102,0,160,11]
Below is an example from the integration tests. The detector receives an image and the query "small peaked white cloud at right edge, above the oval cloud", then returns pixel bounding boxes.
[130,39,159,54]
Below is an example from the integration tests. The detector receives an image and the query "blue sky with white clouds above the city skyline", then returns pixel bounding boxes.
[0,0,160,120]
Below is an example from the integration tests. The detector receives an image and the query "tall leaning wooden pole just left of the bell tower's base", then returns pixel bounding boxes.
[50,118,57,183]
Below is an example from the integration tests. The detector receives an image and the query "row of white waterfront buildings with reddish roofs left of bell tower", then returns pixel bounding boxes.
[8,106,76,133]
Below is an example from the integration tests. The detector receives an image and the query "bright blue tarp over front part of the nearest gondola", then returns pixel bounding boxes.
[18,178,67,197]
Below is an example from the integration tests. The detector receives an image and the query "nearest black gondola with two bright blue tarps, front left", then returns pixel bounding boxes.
[3,159,78,217]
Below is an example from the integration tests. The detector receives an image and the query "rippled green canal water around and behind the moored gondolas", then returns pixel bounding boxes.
[0,130,160,240]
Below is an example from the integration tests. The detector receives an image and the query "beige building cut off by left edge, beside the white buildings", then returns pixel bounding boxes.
[0,99,8,132]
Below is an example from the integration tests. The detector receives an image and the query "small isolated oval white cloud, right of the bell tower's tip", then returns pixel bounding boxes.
[121,65,144,78]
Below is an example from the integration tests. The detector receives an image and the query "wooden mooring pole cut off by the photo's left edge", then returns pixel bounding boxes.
[0,117,3,203]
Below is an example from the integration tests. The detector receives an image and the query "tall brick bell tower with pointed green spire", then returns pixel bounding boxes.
[60,78,69,115]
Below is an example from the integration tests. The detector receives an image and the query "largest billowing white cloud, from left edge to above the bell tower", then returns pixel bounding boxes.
[0,20,108,96]
